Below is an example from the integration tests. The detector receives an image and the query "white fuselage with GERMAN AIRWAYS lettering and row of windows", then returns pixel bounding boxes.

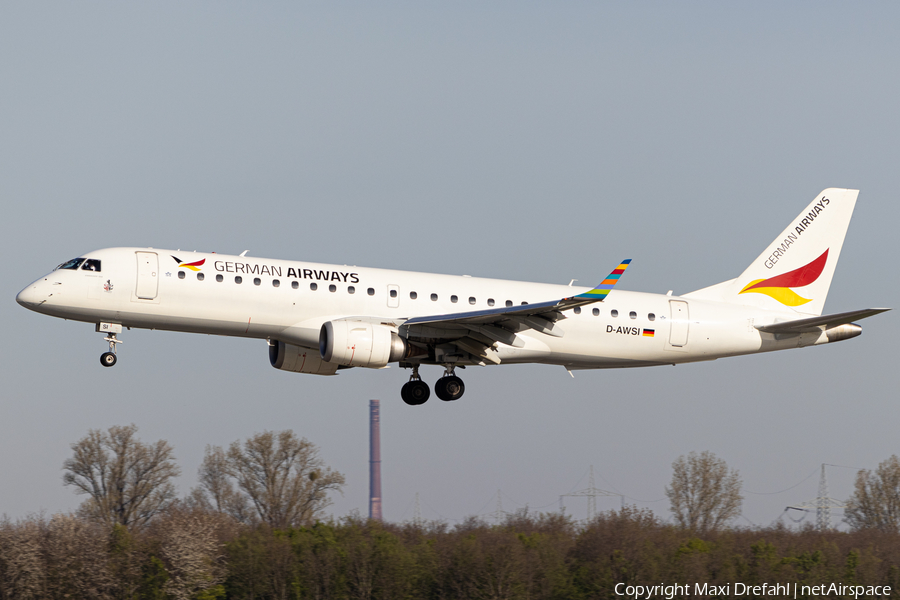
[17,248,827,369]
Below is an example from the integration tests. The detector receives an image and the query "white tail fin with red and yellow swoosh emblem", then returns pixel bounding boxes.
[685,188,859,315]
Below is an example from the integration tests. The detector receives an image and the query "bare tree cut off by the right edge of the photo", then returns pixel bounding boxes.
[844,454,900,533]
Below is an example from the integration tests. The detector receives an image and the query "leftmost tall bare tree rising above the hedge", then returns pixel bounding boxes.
[63,424,180,528]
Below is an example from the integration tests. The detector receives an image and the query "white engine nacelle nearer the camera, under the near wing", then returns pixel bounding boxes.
[319,320,409,369]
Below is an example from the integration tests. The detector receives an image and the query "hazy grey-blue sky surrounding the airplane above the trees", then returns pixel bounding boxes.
[0,1,900,524]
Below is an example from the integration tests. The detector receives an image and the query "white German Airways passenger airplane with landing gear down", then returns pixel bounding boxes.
[16,188,890,405]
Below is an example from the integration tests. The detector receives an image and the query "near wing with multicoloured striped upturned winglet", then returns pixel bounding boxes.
[400,258,631,364]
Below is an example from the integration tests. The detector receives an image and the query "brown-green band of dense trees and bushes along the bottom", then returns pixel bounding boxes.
[0,502,900,600]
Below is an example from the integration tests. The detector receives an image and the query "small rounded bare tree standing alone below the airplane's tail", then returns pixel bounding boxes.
[666,450,744,533]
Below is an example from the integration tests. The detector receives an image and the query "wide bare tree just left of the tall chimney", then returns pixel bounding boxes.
[199,430,344,528]
